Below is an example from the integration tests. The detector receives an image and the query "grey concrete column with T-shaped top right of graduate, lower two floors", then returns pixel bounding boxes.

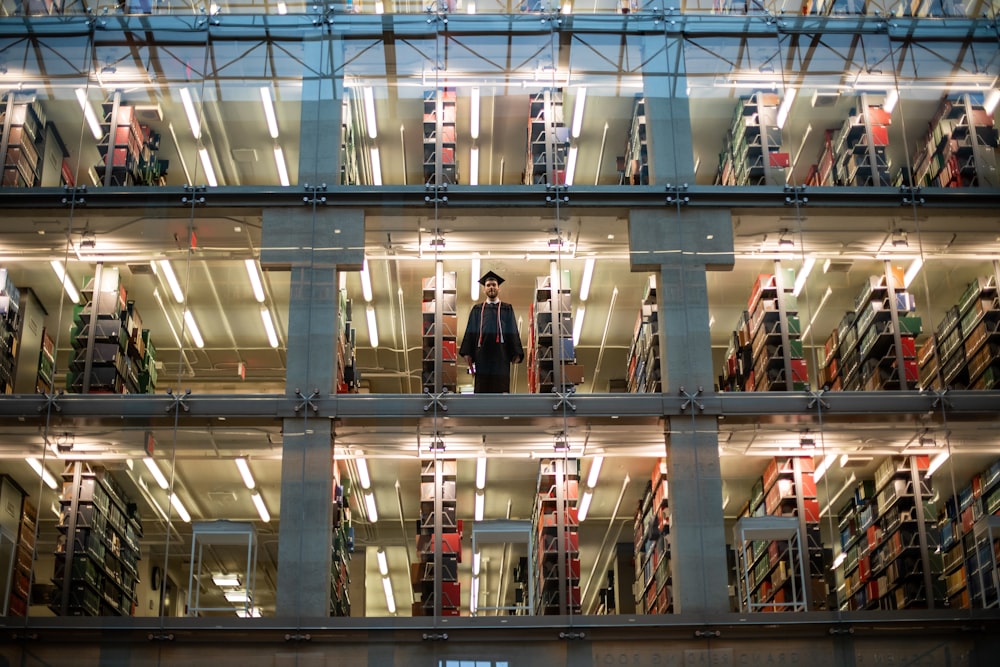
[629,209,733,615]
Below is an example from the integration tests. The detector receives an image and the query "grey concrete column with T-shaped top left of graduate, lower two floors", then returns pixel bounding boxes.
[260,206,364,618]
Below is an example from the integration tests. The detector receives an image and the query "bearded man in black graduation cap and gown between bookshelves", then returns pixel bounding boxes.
[458,271,524,394]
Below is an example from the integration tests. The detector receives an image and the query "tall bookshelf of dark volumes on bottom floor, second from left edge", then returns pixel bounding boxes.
[49,461,142,616]
